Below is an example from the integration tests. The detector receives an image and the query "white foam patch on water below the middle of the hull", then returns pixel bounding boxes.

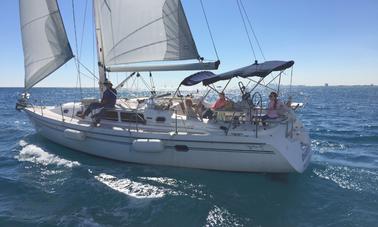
[95,173,168,199]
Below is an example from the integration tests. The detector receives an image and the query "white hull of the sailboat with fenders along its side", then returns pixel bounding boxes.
[25,103,311,173]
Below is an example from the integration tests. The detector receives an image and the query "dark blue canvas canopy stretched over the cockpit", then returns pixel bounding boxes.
[181,61,294,86]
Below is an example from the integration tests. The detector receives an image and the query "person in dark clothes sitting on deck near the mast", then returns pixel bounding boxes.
[79,80,117,119]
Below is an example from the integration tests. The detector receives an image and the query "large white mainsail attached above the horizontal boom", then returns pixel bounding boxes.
[95,0,199,66]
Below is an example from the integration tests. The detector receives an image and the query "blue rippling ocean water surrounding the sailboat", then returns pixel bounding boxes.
[0,86,378,226]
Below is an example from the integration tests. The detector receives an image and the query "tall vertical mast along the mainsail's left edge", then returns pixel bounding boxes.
[92,0,106,95]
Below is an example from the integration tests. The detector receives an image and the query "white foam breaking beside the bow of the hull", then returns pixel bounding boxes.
[15,144,80,168]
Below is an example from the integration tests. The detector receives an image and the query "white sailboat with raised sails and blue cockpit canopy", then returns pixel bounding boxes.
[17,0,312,173]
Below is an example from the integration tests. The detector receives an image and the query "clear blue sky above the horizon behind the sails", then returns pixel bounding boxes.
[0,0,378,88]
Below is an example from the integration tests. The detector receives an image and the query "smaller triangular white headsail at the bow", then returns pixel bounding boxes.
[20,0,73,89]
